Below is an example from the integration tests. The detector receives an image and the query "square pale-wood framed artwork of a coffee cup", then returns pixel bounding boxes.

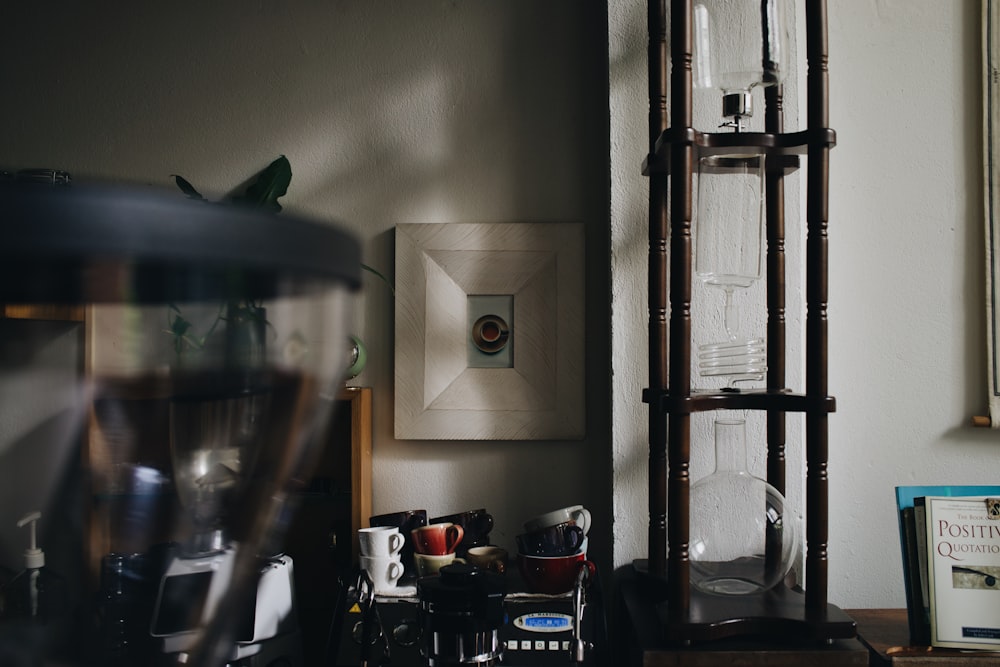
[395,223,585,440]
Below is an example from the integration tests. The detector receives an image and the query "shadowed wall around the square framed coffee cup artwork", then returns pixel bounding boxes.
[0,0,611,566]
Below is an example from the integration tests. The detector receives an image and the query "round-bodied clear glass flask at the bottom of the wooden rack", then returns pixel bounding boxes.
[689,419,799,595]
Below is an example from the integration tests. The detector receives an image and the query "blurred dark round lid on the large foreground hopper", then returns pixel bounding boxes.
[0,182,361,303]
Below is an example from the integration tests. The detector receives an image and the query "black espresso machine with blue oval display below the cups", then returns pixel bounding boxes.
[331,563,608,667]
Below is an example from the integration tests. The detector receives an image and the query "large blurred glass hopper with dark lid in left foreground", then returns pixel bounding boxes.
[0,184,360,667]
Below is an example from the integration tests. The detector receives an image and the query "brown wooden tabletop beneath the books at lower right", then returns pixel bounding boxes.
[845,609,1000,667]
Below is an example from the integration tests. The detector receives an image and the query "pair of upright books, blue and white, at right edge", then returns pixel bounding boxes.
[896,486,1000,651]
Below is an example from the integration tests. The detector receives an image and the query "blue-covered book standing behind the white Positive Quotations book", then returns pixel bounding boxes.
[896,485,1000,646]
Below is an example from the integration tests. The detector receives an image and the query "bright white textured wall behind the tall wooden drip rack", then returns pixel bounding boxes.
[609,0,1000,608]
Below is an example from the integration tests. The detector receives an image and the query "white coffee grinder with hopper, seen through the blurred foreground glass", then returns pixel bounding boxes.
[150,328,302,667]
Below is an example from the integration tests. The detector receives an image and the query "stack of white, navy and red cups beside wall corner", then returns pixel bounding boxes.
[517,505,596,595]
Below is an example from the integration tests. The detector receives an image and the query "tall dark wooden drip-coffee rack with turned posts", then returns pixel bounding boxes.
[632,0,856,652]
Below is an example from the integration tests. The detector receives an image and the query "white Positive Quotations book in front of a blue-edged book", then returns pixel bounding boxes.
[924,494,1000,650]
